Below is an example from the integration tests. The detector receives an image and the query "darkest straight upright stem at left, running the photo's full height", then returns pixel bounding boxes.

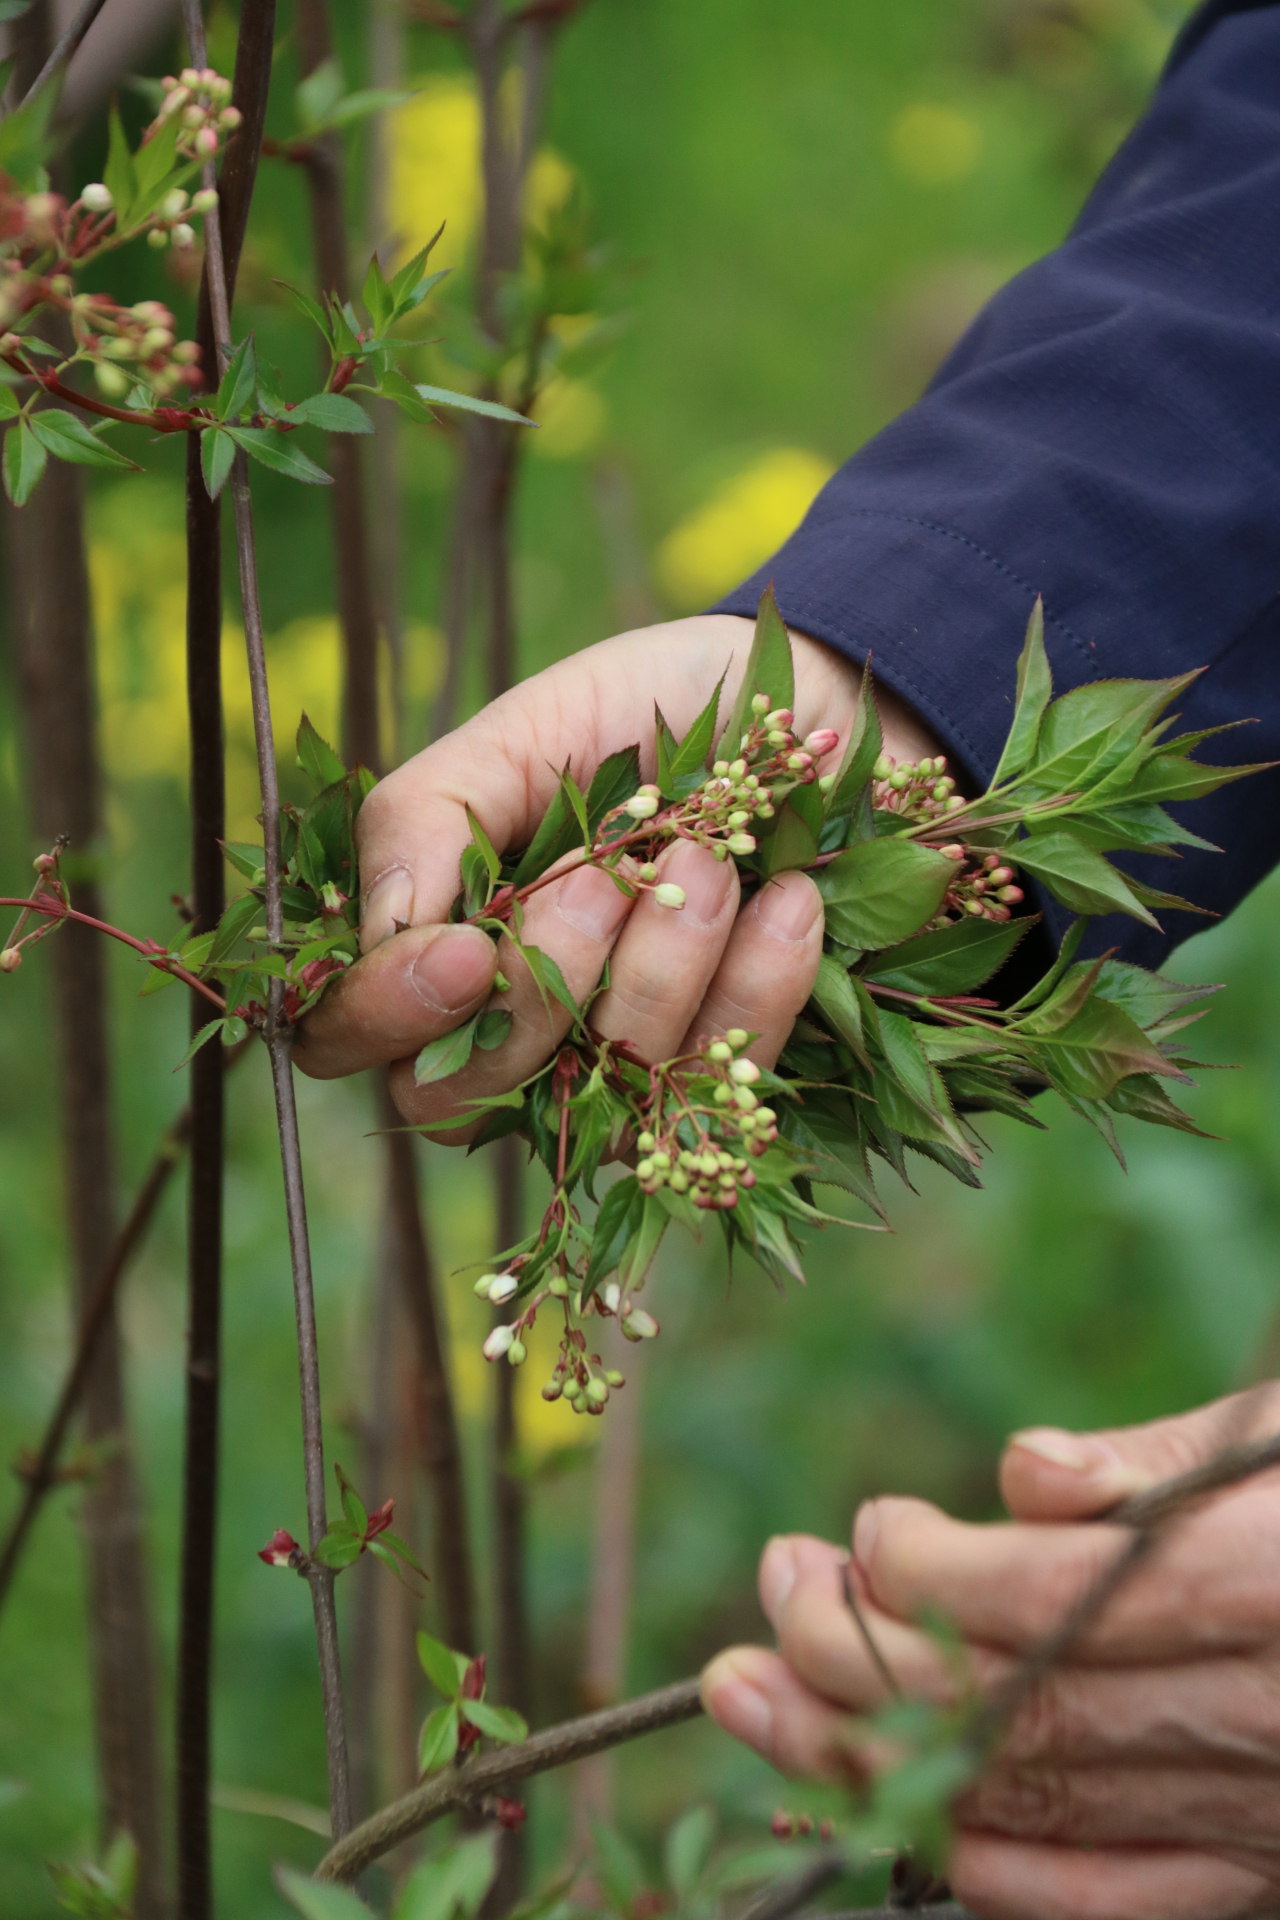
[177,0,274,1920]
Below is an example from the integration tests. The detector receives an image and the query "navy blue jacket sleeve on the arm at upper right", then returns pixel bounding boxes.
[718,0,1280,966]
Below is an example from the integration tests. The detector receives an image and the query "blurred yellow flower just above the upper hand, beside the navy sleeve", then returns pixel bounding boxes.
[656,447,835,609]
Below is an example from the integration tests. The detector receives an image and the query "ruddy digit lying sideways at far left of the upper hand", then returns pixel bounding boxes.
[294,927,497,1079]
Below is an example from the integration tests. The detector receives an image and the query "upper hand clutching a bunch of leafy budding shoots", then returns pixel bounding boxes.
[296,614,936,1144]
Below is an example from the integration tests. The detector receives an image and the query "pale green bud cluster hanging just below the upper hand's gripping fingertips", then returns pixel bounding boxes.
[635,1027,777,1210]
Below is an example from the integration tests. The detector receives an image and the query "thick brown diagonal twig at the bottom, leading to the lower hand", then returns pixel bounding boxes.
[315,1680,702,1882]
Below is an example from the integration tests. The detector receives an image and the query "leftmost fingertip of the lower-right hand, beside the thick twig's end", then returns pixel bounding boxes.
[702,1647,864,1780]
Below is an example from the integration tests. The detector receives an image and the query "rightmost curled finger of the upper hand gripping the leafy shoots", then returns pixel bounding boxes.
[679,874,823,1068]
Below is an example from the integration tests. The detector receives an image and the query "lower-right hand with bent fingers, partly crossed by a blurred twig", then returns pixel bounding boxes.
[702,1392,1280,1920]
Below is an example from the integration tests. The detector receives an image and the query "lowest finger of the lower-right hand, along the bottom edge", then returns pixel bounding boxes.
[946,1832,1276,1920]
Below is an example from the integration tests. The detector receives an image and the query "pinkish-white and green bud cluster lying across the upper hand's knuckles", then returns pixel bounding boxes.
[620,693,839,879]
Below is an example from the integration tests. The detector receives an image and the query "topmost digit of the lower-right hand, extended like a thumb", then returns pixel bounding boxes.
[1000,1386,1280,1521]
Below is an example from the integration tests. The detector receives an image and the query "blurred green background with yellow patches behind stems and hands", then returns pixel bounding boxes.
[0,0,1280,1920]
